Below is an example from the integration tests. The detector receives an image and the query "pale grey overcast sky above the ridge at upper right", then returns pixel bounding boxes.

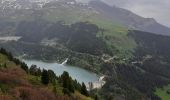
[78,0,170,27]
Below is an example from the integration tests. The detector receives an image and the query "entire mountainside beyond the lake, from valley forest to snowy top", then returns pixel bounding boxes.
[0,0,170,100]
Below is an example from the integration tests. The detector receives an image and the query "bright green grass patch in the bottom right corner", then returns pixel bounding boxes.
[155,85,170,100]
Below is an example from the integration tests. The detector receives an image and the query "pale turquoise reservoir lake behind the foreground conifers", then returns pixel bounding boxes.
[23,60,99,84]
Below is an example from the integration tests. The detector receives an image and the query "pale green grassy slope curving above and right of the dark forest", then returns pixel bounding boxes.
[2,6,136,59]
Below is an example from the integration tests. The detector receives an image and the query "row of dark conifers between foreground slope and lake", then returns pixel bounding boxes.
[0,48,89,96]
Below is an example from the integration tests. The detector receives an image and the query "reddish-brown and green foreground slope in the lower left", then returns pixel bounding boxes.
[0,53,92,100]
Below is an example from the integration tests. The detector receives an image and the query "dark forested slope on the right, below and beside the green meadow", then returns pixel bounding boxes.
[97,31,170,100]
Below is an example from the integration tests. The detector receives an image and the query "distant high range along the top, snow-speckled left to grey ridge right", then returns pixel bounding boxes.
[0,0,170,36]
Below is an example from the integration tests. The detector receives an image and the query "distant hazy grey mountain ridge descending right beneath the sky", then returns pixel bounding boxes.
[89,0,170,36]
